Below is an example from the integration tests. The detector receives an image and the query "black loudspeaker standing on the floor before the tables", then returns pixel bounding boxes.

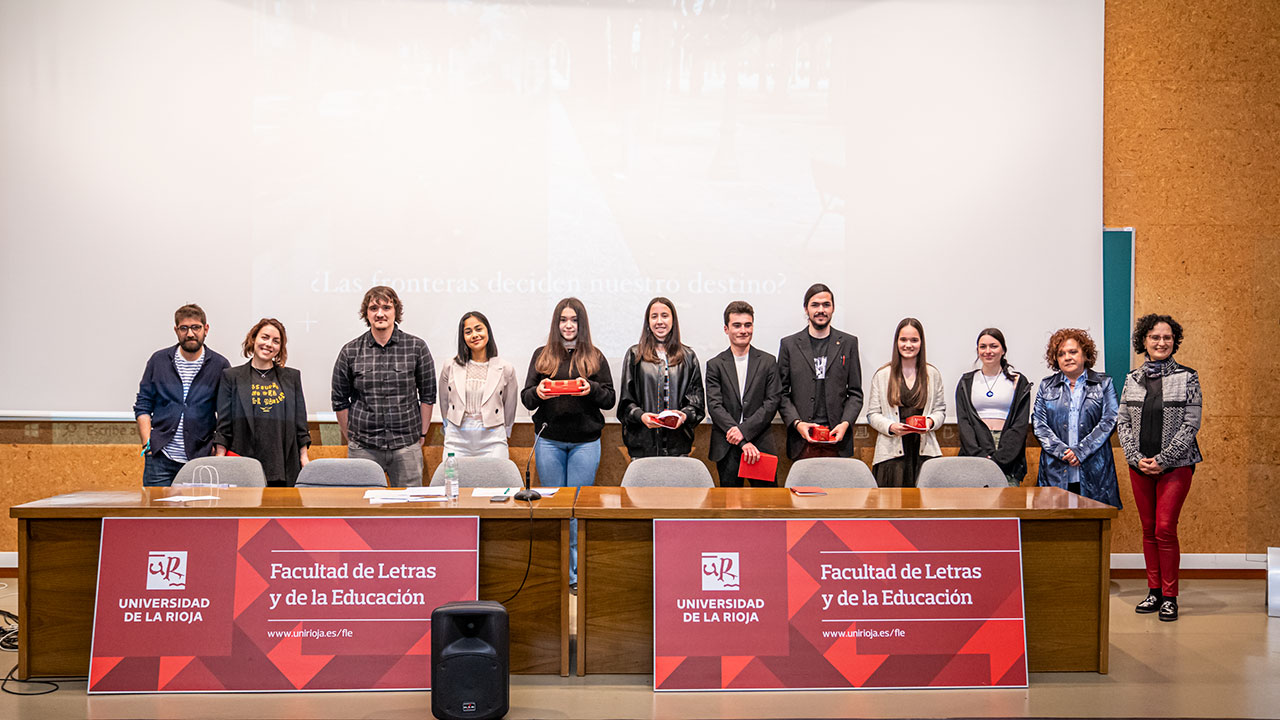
[431,601,511,720]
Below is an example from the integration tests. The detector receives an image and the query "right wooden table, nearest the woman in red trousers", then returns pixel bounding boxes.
[573,487,1117,675]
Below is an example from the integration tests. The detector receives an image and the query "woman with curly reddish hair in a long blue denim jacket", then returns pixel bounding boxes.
[1033,328,1120,507]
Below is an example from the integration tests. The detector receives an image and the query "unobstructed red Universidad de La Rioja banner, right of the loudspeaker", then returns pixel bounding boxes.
[653,518,1027,691]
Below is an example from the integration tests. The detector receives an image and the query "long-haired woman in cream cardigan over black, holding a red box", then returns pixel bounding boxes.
[867,318,947,488]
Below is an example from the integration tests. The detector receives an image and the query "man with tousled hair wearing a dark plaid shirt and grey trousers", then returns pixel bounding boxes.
[333,286,435,487]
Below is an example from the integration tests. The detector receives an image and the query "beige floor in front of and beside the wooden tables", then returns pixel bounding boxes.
[0,579,1280,720]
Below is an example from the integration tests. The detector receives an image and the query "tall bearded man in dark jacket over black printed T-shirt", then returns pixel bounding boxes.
[778,283,863,460]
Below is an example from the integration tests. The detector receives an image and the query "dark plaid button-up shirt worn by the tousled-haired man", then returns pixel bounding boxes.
[333,325,435,450]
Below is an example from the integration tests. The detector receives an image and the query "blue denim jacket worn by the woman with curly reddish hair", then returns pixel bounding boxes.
[1033,370,1120,507]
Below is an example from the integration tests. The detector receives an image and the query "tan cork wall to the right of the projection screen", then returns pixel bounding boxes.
[1103,0,1280,552]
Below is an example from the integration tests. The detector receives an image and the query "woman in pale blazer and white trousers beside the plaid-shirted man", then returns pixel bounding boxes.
[440,310,520,459]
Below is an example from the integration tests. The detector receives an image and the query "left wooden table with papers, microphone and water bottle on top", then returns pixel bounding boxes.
[9,488,573,679]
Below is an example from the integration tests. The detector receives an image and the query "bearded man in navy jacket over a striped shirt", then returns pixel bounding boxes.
[133,299,230,486]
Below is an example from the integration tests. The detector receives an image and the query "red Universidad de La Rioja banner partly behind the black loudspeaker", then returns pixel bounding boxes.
[88,516,480,693]
